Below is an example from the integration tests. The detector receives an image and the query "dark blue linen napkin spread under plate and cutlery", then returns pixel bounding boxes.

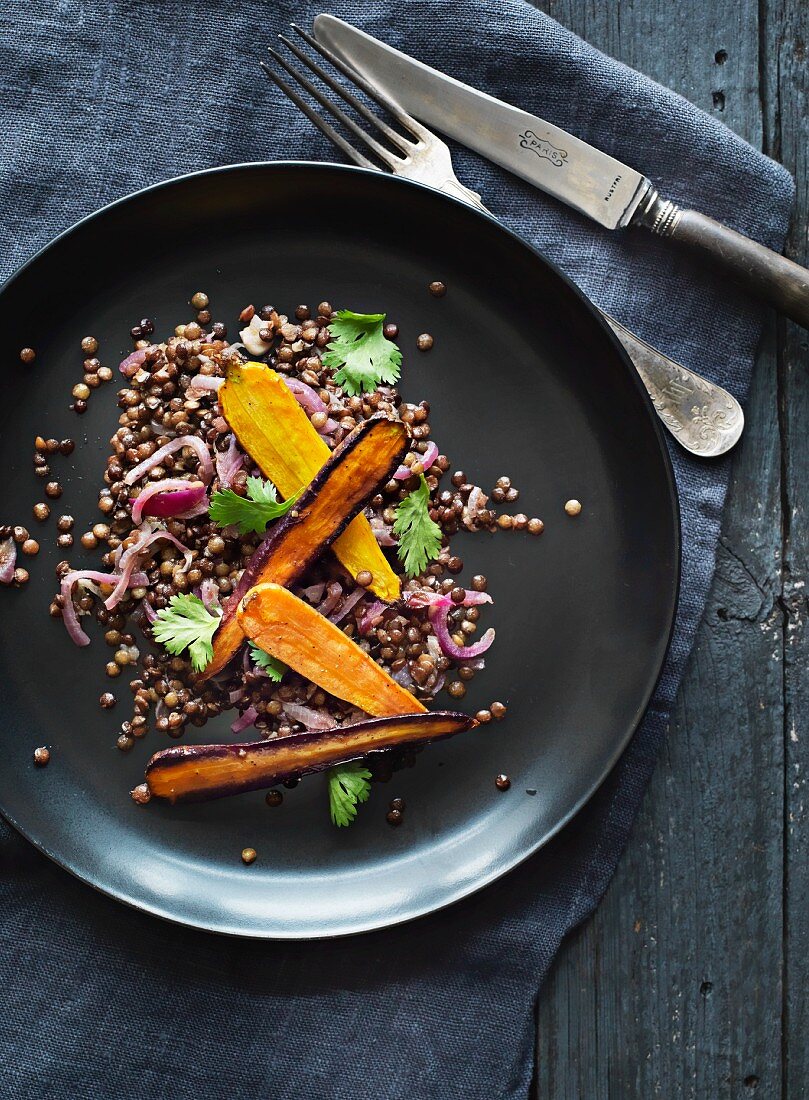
[0,0,792,1100]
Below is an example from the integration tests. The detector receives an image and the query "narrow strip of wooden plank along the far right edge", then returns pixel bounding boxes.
[763,0,809,1100]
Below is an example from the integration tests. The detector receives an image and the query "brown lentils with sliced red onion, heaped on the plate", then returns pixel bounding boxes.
[37,290,543,824]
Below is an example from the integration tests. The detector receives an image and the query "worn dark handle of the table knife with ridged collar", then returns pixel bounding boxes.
[639,196,809,329]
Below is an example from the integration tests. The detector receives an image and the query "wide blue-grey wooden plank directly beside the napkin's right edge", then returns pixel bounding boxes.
[528,0,798,1100]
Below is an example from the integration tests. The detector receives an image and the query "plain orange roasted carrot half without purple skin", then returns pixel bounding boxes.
[238,584,425,718]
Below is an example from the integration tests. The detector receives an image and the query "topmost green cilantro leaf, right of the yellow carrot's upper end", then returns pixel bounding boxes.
[322,309,402,397]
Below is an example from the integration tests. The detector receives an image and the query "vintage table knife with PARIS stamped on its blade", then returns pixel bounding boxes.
[315,14,809,328]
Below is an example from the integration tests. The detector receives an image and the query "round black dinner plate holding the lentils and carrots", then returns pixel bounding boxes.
[0,164,679,938]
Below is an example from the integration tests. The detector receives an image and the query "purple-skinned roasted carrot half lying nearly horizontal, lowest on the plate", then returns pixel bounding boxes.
[145,711,477,802]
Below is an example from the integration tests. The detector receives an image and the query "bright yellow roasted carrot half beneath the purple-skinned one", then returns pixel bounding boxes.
[219,363,402,603]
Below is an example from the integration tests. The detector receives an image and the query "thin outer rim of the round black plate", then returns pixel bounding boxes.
[0,160,682,943]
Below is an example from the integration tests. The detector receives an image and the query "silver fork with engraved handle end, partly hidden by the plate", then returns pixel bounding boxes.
[259,23,744,458]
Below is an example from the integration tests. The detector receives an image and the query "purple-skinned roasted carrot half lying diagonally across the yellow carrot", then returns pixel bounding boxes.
[201,417,408,680]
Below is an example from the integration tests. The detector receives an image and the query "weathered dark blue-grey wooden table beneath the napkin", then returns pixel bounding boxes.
[535,0,809,1100]
